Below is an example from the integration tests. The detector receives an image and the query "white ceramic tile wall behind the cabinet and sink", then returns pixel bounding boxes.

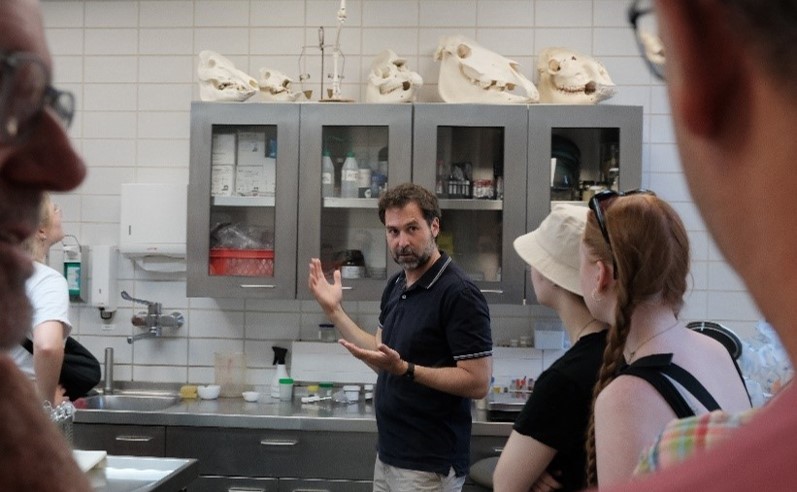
[38,0,759,384]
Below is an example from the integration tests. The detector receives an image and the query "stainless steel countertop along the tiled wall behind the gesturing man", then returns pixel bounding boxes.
[75,394,512,436]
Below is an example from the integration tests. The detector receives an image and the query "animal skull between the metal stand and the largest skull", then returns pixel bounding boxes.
[365,50,423,103]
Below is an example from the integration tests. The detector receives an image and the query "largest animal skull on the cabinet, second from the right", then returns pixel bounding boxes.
[435,36,539,104]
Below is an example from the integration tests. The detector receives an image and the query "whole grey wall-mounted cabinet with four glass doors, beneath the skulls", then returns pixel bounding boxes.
[187,103,642,304]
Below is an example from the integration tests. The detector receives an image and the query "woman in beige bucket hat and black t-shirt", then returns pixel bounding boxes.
[493,204,606,491]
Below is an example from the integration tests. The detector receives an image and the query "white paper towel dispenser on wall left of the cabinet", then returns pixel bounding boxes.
[119,183,188,258]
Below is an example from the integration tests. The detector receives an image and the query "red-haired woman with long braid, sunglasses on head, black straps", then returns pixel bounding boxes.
[581,190,750,488]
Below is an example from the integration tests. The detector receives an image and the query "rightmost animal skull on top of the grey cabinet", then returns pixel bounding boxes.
[537,48,615,104]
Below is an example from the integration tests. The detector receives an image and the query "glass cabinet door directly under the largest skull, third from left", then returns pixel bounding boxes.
[413,104,528,303]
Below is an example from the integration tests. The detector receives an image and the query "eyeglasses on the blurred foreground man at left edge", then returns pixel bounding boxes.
[0,52,75,145]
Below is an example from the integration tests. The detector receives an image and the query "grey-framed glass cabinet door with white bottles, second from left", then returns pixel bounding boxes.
[297,103,412,301]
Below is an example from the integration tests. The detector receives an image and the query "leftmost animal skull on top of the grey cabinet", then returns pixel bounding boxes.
[197,50,258,101]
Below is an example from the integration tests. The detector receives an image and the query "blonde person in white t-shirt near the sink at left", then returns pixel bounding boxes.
[11,193,72,406]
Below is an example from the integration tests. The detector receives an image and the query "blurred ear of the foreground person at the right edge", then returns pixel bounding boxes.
[656,0,746,138]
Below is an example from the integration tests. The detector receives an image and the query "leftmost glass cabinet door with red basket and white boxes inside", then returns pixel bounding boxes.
[188,103,299,298]
